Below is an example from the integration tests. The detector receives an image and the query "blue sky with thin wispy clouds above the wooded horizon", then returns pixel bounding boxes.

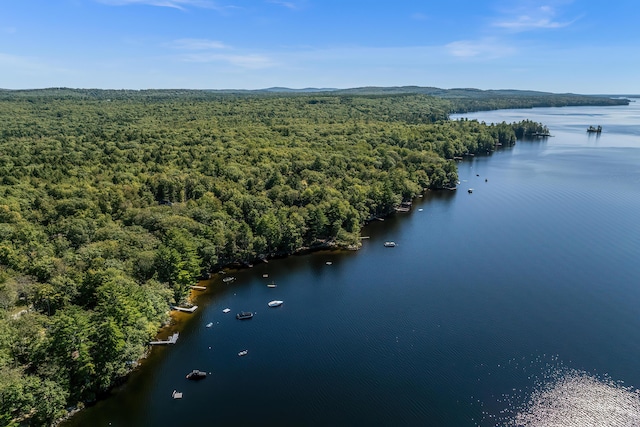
[0,0,640,94]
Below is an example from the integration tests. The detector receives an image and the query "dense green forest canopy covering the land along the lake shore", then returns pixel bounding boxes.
[0,89,620,425]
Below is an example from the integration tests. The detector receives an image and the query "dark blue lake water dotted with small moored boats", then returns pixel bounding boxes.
[65,102,640,427]
